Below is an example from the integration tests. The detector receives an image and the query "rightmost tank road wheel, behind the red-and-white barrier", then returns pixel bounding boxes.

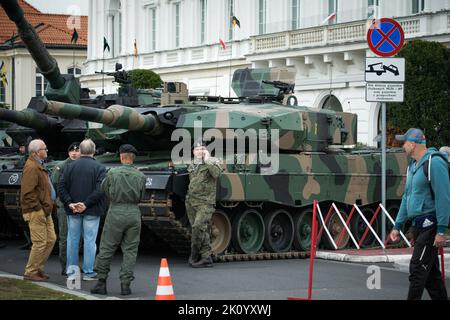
[350,207,381,248]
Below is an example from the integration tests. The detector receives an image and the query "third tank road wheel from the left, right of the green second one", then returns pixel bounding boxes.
[264,209,294,252]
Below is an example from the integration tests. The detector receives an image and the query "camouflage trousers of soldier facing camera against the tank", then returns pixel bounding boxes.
[186,199,215,258]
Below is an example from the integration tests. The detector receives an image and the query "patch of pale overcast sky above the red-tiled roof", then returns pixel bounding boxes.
[25,0,89,16]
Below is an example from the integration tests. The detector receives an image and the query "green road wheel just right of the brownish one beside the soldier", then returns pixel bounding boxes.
[232,209,264,253]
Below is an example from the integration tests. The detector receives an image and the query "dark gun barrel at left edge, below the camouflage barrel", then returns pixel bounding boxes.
[0,108,57,130]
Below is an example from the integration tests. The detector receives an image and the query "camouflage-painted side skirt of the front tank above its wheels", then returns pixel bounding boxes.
[217,152,407,207]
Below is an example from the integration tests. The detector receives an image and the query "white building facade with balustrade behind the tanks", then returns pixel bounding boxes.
[81,0,450,145]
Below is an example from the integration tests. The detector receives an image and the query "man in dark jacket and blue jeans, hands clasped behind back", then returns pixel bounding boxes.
[59,139,106,280]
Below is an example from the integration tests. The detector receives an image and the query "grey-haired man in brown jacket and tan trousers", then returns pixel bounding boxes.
[20,139,56,281]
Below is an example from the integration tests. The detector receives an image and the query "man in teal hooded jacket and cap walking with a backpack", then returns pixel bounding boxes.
[390,128,450,300]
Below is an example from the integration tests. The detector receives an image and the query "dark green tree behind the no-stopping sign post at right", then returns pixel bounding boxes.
[387,40,450,147]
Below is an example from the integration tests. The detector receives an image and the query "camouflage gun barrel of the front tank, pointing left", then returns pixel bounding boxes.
[37,101,160,133]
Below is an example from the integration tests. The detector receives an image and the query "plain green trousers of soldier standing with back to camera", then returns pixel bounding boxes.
[94,203,141,284]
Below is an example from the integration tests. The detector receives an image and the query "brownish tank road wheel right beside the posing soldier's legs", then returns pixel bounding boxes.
[211,210,231,254]
